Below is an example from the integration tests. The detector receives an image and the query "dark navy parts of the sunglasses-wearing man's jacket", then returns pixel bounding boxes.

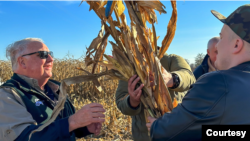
[2,74,91,141]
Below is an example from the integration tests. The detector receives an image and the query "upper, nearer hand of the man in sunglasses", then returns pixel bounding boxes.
[69,103,105,132]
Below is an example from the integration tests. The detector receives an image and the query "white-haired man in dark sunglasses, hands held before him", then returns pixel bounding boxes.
[0,38,105,141]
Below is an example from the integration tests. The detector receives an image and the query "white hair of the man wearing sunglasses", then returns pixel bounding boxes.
[6,38,44,71]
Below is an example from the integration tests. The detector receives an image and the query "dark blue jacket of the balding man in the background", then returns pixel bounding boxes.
[193,55,209,80]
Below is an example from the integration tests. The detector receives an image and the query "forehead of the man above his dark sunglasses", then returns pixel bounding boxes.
[25,41,49,53]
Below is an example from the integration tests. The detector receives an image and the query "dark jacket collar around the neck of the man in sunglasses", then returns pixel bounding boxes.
[11,73,59,93]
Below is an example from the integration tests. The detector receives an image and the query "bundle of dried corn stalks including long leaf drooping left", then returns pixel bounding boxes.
[29,0,177,138]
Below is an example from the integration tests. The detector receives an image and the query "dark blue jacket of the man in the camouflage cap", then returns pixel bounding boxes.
[150,61,250,141]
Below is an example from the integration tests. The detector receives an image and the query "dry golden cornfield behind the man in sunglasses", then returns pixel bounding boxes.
[0,58,132,141]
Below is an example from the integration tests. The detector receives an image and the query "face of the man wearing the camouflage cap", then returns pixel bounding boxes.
[215,24,234,70]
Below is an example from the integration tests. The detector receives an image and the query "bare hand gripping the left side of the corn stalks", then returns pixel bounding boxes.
[128,75,144,107]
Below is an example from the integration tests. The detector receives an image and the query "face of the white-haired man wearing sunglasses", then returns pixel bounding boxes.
[23,42,54,80]
